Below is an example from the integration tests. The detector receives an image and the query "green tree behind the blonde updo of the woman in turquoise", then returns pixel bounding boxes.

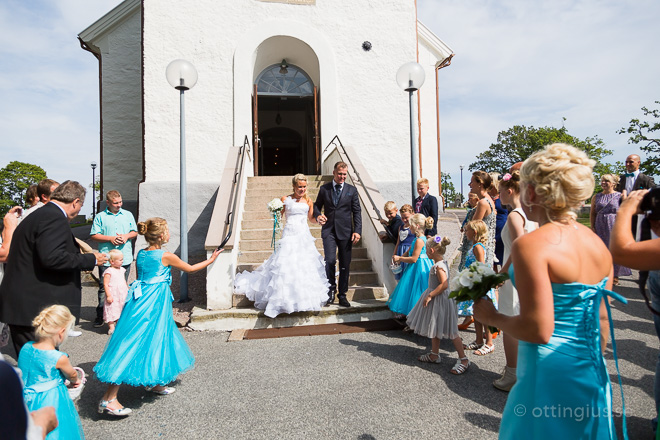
[468,125,615,192]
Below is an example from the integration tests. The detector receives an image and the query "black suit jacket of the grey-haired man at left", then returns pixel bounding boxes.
[0,203,96,326]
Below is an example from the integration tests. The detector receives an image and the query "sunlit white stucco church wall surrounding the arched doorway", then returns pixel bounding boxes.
[144,0,426,181]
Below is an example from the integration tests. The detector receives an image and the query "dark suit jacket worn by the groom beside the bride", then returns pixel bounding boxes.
[314,181,362,240]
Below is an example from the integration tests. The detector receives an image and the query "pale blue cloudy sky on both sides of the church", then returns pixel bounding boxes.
[0,0,660,214]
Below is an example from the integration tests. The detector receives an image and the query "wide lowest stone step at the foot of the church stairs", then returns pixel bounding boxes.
[188,299,394,331]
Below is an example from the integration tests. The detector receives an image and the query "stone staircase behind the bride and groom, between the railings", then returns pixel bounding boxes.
[233,176,387,308]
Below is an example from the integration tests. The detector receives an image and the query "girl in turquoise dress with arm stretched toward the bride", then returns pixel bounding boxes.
[94,217,222,416]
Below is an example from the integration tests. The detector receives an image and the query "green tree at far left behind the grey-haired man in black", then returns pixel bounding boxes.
[0,161,46,217]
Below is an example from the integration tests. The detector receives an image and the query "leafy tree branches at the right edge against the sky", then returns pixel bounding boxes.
[617,101,660,176]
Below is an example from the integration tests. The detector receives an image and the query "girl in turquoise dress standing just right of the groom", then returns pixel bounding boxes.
[387,214,433,316]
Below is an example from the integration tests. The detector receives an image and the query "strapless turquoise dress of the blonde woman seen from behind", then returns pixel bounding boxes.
[499,266,628,440]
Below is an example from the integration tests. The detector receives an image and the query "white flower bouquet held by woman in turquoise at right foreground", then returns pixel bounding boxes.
[449,261,509,332]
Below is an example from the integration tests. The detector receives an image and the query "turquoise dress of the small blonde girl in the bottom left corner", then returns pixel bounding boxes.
[18,342,85,440]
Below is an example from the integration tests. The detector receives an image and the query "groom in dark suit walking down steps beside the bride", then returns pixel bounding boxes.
[314,162,362,307]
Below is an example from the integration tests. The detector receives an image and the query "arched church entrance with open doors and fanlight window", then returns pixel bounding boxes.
[252,36,321,176]
